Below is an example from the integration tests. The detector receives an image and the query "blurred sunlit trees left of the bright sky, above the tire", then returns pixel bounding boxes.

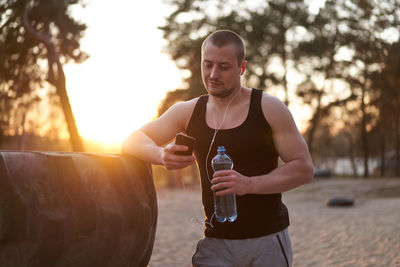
[0,0,87,151]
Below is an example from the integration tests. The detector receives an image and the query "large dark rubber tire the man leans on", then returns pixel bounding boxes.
[0,151,157,267]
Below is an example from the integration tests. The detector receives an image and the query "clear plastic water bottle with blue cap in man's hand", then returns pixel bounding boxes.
[211,146,237,222]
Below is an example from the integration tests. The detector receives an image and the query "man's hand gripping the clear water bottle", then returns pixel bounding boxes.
[211,170,251,196]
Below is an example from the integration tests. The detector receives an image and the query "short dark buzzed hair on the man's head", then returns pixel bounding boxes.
[201,30,246,66]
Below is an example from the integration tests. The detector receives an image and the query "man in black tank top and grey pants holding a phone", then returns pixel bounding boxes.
[122,30,313,267]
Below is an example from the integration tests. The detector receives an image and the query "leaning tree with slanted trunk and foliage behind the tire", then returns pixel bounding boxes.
[0,0,87,151]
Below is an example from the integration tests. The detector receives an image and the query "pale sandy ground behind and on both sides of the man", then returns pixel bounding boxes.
[149,179,400,267]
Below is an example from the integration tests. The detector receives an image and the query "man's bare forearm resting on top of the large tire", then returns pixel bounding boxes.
[122,130,162,165]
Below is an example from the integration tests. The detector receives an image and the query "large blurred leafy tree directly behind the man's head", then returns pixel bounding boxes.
[159,0,307,114]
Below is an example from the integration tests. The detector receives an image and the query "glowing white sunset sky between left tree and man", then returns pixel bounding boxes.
[64,0,181,147]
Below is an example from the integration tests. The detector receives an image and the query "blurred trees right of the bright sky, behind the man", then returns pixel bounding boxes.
[159,0,400,177]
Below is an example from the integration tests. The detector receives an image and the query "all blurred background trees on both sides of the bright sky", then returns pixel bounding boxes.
[0,0,400,177]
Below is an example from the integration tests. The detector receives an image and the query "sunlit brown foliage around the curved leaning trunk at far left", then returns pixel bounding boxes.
[0,0,87,149]
